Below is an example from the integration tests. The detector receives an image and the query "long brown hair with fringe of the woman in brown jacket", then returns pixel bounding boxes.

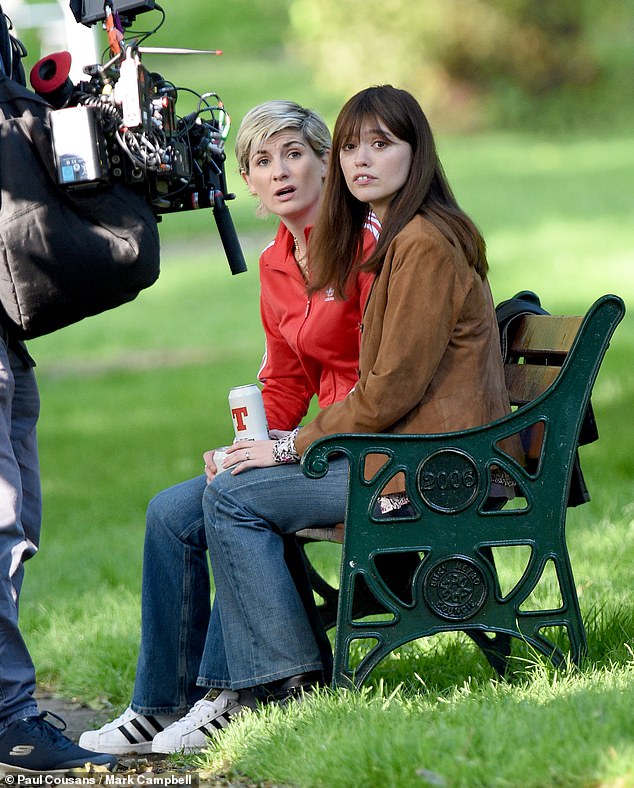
[309,85,488,298]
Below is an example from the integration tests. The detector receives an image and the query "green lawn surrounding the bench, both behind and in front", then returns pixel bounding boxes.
[21,127,634,788]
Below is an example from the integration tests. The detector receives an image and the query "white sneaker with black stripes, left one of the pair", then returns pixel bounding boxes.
[79,706,179,755]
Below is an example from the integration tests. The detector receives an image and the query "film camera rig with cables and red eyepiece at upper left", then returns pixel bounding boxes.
[30,0,246,274]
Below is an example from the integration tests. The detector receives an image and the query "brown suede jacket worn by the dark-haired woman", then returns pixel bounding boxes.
[295,216,510,464]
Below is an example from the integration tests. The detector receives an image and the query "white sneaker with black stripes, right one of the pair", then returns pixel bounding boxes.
[152,689,247,753]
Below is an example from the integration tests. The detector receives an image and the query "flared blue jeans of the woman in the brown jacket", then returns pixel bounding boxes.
[203,459,348,690]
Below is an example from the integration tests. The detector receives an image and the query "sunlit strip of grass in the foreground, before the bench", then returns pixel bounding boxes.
[196,663,634,788]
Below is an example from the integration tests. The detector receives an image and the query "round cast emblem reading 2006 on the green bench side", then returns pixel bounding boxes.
[418,449,480,513]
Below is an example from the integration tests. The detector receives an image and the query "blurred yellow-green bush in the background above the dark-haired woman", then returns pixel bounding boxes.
[290,0,633,128]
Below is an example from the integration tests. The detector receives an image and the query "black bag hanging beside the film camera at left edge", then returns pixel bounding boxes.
[0,76,160,339]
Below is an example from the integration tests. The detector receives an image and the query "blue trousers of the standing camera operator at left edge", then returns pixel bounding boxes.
[0,338,42,730]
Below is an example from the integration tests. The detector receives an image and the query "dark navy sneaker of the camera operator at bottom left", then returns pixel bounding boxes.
[0,711,117,775]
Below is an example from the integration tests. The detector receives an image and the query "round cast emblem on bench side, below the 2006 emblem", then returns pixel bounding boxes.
[423,555,488,621]
